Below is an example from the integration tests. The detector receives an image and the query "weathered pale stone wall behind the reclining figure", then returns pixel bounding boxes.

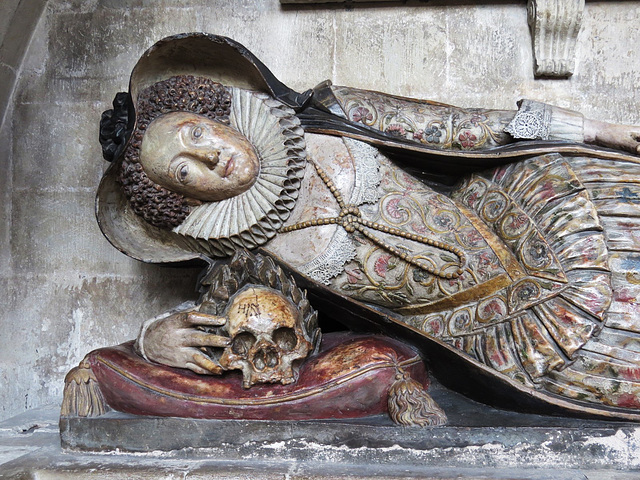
[0,0,640,419]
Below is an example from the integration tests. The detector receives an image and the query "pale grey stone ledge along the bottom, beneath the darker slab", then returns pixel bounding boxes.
[0,447,604,480]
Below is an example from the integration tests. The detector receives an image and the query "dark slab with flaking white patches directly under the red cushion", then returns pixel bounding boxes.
[60,412,640,474]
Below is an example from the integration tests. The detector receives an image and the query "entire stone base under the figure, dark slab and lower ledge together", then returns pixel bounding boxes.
[0,386,640,480]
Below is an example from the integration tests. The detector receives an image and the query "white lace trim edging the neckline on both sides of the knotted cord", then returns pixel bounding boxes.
[298,138,382,285]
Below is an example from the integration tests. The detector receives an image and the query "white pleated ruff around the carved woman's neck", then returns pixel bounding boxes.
[173,88,306,256]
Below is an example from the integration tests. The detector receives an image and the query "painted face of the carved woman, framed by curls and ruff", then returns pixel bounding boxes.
[140,112,260,202]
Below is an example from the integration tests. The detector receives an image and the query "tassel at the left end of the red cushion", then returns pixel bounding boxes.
[60,357,111,417]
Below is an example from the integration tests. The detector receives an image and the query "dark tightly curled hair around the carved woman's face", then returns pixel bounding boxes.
[119,75,231,229]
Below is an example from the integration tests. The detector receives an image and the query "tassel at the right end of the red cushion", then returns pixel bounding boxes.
[387,367,447,427]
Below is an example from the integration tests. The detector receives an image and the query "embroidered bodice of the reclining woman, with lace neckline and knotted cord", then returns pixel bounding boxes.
[267,133,504,308]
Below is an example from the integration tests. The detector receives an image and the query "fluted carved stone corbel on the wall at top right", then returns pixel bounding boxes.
[528,0,584,77]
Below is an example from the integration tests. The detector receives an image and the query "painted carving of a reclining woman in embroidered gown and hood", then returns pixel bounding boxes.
[98,34,640,419]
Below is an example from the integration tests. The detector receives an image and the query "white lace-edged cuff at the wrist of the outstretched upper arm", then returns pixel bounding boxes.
[504,100,584,143]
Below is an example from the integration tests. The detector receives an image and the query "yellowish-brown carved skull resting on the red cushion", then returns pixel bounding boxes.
[220,286,313,388]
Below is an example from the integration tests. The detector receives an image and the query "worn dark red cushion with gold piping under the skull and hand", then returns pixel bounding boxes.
[88,333,428,420]
